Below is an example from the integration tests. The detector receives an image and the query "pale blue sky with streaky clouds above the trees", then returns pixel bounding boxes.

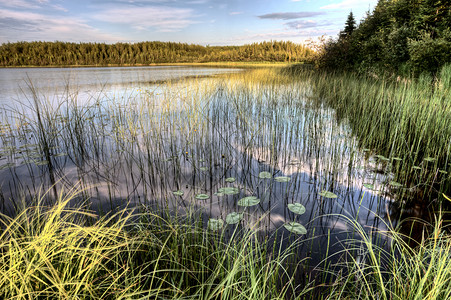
[0,0,377,45]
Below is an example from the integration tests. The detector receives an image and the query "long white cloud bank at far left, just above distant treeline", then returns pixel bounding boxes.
[0,9,125,43]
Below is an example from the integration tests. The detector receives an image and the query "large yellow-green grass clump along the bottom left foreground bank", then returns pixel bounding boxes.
[0,186,314,299]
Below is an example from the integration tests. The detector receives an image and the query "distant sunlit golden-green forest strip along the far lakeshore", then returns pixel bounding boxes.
[0,41,314,67]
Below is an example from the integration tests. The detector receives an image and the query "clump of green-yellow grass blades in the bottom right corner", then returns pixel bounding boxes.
[324,198,451,300]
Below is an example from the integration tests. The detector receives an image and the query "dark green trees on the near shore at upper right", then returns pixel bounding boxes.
[318,0,451,75]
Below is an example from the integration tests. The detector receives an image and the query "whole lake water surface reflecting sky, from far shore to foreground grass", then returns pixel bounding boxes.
[0,67,398,270]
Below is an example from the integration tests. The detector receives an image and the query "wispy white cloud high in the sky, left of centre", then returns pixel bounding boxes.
[92,6,196,32]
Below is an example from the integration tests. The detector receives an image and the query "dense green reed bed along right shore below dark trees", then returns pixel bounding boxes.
[291,65,451,201]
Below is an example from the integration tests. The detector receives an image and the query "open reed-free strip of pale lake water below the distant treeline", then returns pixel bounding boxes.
[0,66,239,106]
